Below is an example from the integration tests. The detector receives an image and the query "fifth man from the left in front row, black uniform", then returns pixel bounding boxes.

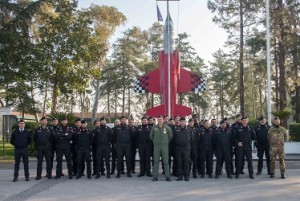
[93,117,112,179]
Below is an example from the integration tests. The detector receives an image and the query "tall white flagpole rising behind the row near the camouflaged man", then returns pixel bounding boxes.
[266,0,272,124]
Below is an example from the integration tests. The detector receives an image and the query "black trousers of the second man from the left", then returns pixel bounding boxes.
[36,147,52,177]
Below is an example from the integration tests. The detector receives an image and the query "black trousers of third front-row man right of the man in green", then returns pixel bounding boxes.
[216,150,232,175]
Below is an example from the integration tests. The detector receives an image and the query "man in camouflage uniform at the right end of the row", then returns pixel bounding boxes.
[268,117,287,179]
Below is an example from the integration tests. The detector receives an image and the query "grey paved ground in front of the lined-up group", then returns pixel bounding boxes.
[0,160,300,201]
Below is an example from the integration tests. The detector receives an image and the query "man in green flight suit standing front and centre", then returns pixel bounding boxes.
[150,116,173,181]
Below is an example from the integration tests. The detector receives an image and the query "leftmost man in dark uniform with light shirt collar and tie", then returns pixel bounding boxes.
[10,119,32,182]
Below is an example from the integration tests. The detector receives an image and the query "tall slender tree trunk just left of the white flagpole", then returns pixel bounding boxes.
[239,0,245,116]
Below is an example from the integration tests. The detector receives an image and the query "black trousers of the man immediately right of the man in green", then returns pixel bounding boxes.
[176,148,191,178]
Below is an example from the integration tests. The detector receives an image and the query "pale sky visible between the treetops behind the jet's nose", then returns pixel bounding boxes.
[78,0,227,64]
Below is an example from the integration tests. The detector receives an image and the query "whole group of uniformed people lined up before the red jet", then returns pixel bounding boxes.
[10,115,287,182]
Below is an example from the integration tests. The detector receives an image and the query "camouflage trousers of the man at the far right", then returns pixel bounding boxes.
[270,147,285,174]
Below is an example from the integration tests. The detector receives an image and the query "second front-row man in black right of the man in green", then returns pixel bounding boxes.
[198,120,213,178]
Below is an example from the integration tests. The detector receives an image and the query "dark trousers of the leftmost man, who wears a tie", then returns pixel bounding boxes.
[14,147,29,178]
